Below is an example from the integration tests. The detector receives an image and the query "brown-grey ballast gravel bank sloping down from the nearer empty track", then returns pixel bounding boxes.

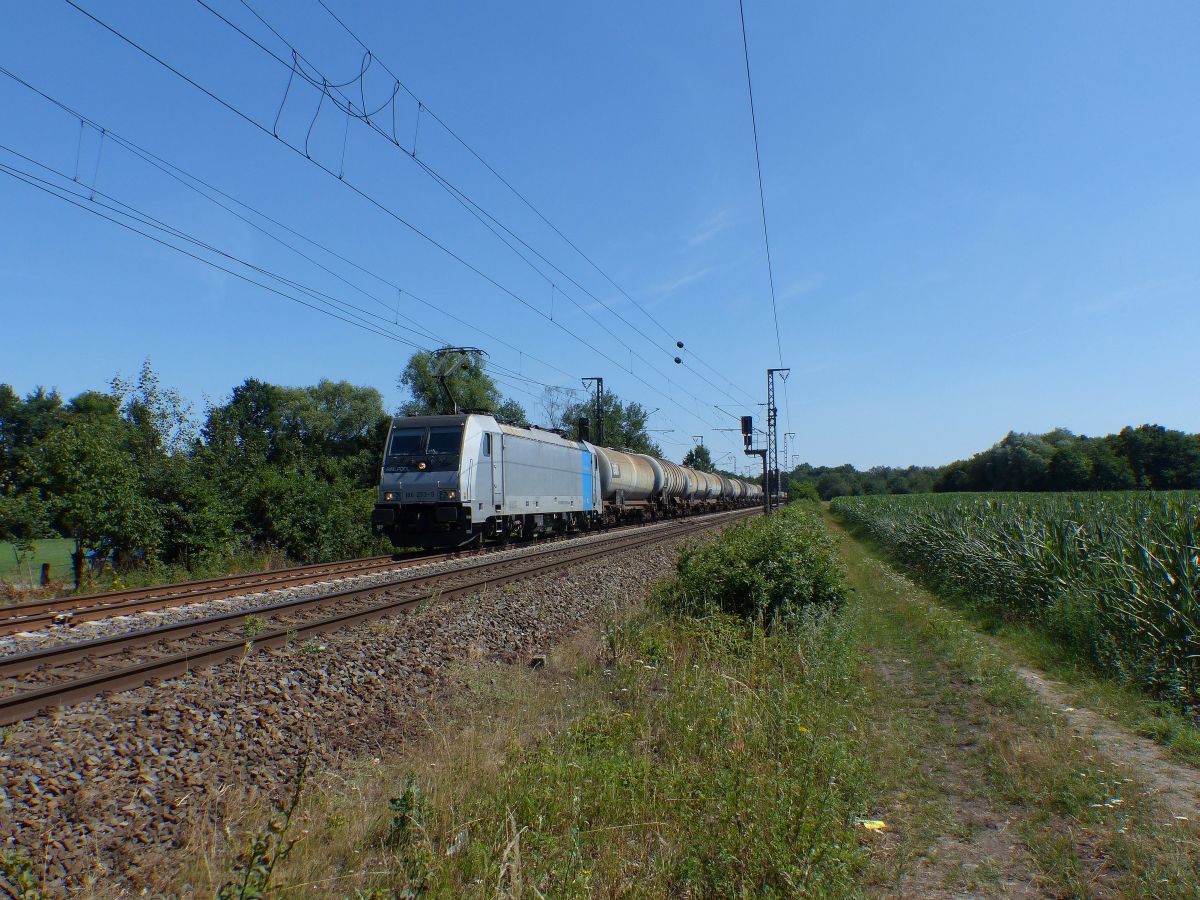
[0,532,712,896]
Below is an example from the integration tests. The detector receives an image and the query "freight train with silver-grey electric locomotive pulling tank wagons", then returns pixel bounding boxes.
[371,413,762,547]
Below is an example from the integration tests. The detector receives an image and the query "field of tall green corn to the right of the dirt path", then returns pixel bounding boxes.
[833,492,1200,715]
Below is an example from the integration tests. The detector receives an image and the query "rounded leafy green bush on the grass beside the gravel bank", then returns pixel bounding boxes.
[665,504,846,626]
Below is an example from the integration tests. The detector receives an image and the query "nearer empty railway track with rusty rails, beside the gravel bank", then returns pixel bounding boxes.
[0,510,756,725]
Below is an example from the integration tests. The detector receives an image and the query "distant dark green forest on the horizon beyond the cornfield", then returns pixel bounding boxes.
[784,425,1200,500]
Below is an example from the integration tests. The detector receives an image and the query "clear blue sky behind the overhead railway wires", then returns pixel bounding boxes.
[0,0,1200,467]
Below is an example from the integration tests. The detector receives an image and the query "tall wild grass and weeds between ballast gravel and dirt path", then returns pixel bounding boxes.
[199,512,874,896]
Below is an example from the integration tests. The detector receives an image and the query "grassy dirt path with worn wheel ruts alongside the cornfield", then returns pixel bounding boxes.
[830,521,1200,898]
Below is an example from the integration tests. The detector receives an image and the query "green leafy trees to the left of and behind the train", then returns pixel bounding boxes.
[0,352,658,584]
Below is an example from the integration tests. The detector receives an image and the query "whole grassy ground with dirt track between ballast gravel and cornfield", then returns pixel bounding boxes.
[188,514,1200,898]
